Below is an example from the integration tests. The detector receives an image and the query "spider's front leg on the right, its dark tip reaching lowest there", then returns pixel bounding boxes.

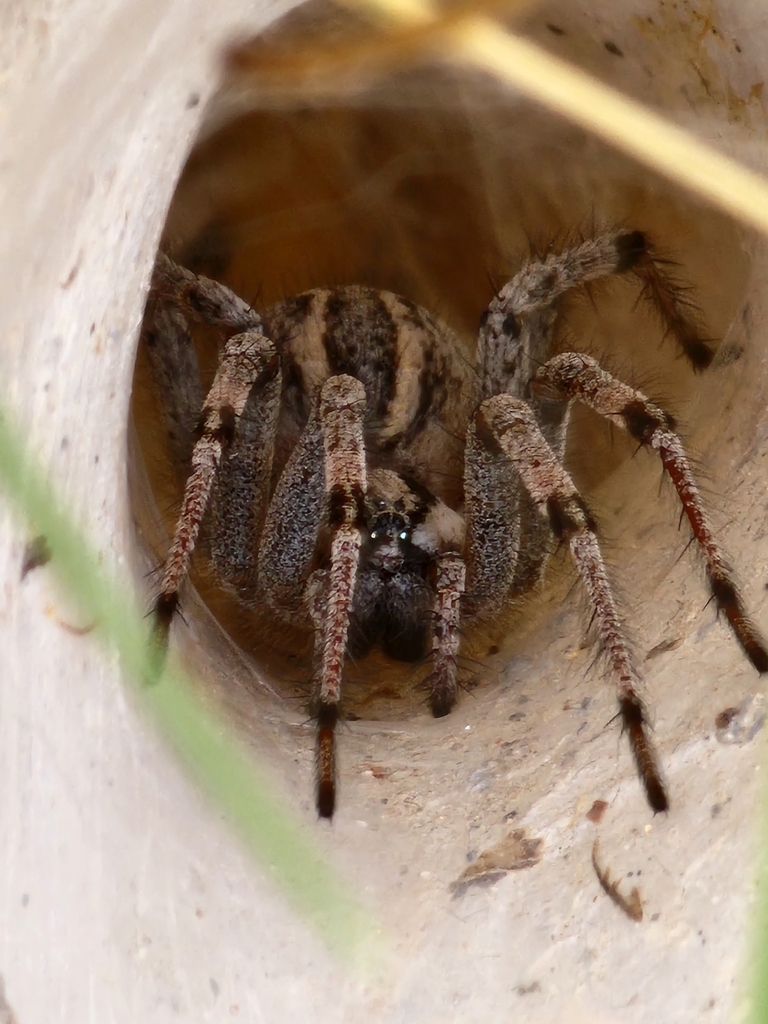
[470,394,669,811]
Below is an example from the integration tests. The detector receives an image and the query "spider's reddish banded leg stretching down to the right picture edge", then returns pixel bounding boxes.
[535,352,768,673]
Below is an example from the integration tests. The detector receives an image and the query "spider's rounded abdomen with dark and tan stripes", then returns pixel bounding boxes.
[262,285,476,505]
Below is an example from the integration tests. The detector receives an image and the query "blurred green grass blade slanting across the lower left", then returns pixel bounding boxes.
[0,410,375,956]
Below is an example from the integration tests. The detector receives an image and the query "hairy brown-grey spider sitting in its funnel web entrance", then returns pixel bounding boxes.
[144,230,768,818]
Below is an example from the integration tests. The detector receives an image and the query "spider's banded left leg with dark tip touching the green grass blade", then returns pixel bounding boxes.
[154,330,280,653]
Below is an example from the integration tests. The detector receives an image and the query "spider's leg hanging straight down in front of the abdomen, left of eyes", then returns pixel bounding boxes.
[305,375,368,818]
